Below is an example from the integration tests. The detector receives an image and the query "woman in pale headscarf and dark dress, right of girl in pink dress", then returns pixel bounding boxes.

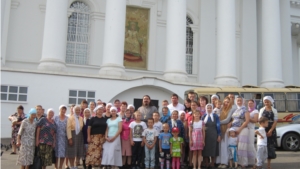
[202,104,221,168]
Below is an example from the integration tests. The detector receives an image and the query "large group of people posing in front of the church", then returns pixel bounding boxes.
[9,92,278,169]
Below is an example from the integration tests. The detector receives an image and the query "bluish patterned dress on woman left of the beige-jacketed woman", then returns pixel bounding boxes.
[54,116,68,158]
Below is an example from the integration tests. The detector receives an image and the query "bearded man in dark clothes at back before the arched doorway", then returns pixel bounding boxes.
[138,95,157,121]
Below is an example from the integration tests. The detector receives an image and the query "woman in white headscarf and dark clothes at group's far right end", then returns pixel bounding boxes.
[258,96,278,169]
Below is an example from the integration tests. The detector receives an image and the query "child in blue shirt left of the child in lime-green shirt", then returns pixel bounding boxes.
[158,123,172,169]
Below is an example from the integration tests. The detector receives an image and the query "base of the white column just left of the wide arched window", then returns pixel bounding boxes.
[38,59,66,72]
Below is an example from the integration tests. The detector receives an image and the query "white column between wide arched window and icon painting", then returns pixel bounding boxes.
[99,0,126,77]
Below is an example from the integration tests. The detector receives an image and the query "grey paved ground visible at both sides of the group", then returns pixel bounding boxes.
[1,139,300,169]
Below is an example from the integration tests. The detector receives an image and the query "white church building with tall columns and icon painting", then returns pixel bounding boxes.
[1,0,300,137]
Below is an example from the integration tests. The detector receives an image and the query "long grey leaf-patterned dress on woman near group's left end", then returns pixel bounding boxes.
[17,119,36,166]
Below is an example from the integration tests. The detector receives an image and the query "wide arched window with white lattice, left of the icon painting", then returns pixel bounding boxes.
[66,2,90,65]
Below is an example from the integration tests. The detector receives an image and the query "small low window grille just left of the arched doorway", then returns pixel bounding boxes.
[69,90,96,104]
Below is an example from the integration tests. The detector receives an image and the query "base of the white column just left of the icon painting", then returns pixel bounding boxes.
[99,64,125,77]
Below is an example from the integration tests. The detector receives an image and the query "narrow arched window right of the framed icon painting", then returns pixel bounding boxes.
[185,16,193,74]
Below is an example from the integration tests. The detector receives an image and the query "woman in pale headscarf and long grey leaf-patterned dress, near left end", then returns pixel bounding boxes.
[17,108,36,169]
